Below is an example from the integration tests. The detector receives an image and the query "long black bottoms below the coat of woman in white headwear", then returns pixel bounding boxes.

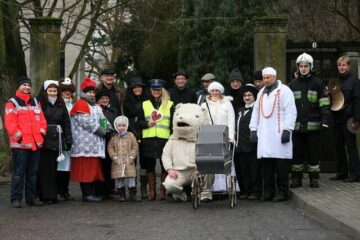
[38,149,59,201]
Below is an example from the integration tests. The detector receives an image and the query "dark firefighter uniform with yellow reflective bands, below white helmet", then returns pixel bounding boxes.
[289,72,330,187]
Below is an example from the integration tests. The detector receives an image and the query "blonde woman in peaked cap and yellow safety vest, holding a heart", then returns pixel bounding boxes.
[139,79,174,201]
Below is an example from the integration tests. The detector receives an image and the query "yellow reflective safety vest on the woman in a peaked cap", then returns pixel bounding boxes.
[142,100,173,139]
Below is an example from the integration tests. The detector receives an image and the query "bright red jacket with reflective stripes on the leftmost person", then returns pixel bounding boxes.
[5,91,47,151]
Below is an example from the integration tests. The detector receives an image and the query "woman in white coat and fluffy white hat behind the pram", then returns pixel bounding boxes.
[201,82,235,202]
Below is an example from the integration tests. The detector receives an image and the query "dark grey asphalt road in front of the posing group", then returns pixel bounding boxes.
[0,182,347,240]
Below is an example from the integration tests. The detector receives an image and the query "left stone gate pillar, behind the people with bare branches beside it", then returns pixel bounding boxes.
[29,17,62,94]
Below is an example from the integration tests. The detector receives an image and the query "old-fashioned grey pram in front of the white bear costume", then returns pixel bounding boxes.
[191,125,236,209]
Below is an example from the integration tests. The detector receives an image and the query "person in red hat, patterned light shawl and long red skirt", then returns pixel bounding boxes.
[70,78,107,202]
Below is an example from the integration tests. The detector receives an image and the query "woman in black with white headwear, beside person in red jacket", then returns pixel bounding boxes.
[38,80,72,204]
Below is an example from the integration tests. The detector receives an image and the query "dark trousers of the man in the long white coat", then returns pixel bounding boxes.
[261,158,289,196]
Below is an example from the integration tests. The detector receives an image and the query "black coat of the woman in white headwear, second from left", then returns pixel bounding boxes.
[42,99,72,151]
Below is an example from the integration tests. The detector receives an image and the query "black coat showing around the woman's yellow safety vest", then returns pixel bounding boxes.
[139,96,175,159]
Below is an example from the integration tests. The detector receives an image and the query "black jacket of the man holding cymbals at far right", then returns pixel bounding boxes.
[332,73,360,123]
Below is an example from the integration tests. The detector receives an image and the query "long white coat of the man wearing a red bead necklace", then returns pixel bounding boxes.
[249,80,297,159]
